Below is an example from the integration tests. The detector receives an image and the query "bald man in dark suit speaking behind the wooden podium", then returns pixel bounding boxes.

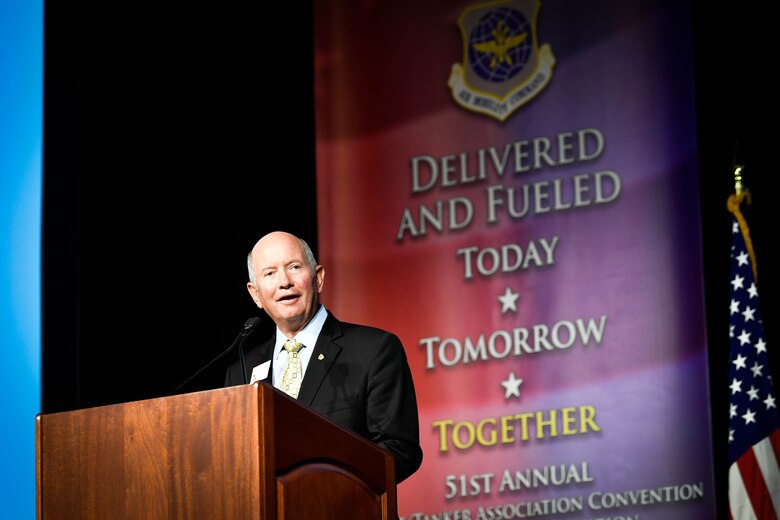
[225,231,422,482]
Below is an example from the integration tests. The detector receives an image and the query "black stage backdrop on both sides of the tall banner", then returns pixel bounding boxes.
[42,1,778,510]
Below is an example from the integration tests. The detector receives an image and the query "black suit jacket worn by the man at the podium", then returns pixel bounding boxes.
[225,313,422,482]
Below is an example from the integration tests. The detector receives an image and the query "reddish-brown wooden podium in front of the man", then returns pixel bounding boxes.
[36,383,397,520]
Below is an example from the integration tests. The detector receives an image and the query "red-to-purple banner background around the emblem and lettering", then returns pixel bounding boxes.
[314,0,714,519]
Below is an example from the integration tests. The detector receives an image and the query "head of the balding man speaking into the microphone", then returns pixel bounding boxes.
[247,233,325,337]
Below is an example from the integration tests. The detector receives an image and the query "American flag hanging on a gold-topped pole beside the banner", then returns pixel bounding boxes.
[728,203,780,520]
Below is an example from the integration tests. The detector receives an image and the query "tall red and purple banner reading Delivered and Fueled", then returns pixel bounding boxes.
[314,0,715,520]
